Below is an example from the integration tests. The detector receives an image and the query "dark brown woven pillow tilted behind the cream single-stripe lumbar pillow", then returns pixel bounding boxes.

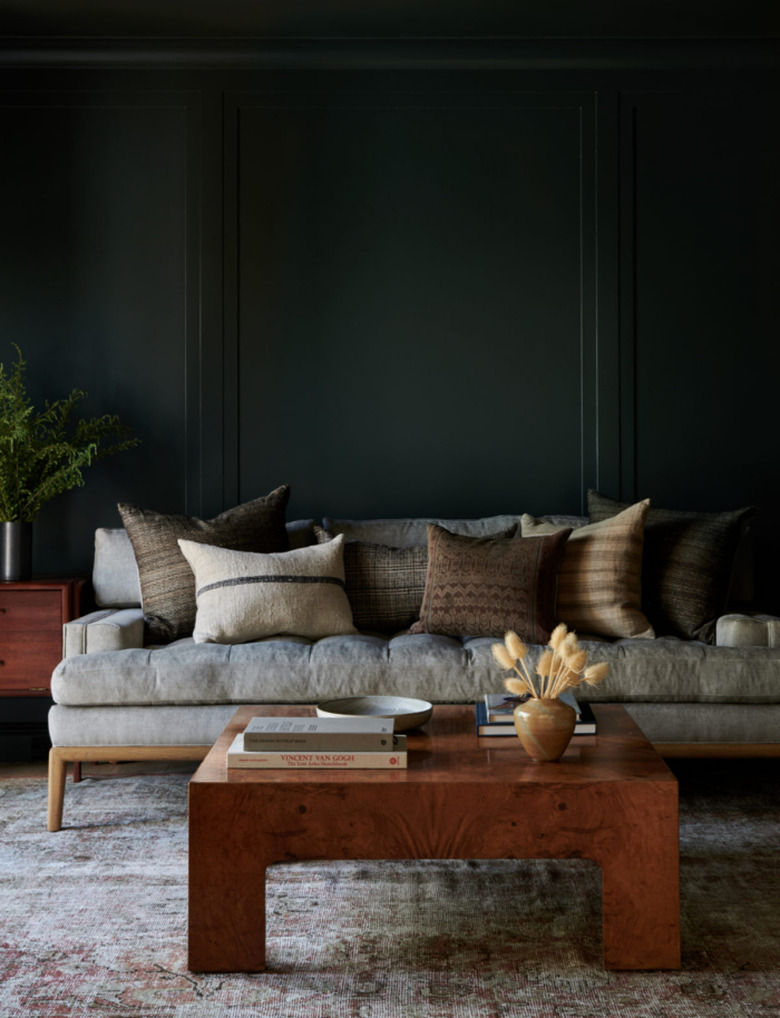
[117,485,290,643]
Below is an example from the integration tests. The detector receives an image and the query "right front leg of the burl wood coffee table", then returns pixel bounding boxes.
[598,798,680,969]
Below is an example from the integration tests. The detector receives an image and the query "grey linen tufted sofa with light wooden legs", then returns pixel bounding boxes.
[49,516,780,830]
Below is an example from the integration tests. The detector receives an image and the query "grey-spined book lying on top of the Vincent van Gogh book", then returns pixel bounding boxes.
[243,717,395,753]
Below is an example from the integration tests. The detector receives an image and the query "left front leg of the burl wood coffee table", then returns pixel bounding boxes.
[187,786,272,972]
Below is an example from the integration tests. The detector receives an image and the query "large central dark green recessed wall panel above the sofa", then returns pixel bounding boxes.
[230,96,595,516]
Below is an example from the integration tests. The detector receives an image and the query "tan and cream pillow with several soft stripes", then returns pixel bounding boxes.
[522,499,656,639]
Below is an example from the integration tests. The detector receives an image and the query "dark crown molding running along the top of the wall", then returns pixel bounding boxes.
[0,37,780,71]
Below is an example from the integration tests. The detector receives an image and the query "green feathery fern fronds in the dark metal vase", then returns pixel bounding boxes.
[0,344,138,522]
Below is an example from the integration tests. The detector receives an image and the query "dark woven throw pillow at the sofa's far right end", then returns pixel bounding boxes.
[588,490,757,643]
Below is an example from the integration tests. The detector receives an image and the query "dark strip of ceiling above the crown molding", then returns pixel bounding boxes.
[0,0,780,40]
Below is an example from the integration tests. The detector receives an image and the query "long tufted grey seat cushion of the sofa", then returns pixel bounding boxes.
[52,633,780,706]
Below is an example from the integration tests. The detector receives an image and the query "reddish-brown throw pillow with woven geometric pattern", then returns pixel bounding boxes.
[409,523,571,643]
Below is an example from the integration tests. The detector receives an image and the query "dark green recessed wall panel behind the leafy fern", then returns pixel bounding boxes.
[0,95,194,573]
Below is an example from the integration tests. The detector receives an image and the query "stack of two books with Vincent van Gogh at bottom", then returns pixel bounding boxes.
[227,718,406,771]
